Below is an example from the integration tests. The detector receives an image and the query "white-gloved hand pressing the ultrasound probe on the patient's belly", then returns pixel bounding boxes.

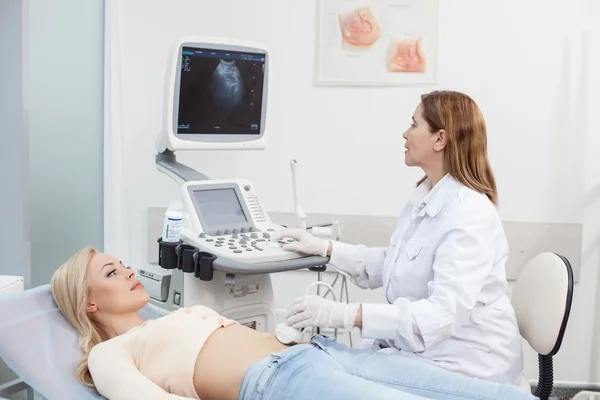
[285,295,360,330]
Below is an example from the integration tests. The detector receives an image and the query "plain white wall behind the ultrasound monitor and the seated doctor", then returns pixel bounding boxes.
[106,0,600,381]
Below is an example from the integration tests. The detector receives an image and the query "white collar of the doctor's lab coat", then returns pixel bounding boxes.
[411,174,463,217]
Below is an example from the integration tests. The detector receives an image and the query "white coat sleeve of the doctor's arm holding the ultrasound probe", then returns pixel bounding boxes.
[355,199,505,352]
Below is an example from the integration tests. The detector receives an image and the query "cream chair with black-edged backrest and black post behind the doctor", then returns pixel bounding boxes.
[511,252,573,400]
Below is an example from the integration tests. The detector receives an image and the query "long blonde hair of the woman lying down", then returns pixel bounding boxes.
[50,247,107,387]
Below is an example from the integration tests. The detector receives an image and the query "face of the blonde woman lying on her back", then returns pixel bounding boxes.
[87,253,150,315]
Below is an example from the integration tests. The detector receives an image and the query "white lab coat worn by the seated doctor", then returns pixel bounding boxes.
[330,175,523,384]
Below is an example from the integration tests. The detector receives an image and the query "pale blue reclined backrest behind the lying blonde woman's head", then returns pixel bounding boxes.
[0,285,160,400]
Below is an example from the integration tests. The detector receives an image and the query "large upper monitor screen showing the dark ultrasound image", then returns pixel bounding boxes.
[175,46,266,135]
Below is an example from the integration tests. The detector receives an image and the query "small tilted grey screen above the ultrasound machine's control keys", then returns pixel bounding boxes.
[193,188,248,229]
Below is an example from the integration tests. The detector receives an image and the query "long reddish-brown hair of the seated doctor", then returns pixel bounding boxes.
[417,91,498,205]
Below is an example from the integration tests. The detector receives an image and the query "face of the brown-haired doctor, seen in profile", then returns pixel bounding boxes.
[402,103,438,168]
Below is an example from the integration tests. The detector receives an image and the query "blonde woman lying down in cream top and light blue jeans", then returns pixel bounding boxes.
[51,248,534,400]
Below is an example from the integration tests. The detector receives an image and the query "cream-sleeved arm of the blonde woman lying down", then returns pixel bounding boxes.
[88,344,191,400]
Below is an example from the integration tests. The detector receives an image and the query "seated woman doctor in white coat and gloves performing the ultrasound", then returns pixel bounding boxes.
[273,91,523,384]
